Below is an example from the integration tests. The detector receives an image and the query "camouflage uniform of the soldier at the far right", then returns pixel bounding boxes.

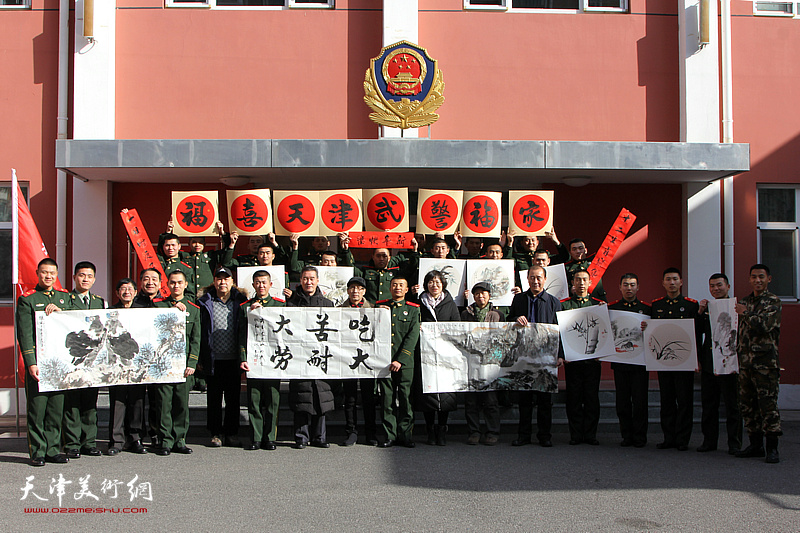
[738,291,783,437]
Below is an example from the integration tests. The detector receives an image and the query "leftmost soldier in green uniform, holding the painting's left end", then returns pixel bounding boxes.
[16,257,69,466]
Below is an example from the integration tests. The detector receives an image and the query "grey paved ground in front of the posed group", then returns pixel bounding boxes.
[0,420,800,533]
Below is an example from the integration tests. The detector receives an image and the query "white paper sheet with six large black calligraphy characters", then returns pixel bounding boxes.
[247,307,392,379]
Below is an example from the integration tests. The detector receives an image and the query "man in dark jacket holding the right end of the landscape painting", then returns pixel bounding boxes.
[508,266,564,448]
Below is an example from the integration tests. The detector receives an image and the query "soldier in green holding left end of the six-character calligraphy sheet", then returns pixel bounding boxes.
[239,270,286,450]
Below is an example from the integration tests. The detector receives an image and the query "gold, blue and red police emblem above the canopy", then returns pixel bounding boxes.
[364,41,444,129]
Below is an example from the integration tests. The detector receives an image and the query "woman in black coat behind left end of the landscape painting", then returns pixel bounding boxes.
[414,270,461,446]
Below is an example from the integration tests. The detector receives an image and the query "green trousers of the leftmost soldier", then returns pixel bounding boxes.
[25,374,64,459]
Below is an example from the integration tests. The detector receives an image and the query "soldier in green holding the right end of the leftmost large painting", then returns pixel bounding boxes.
[155,270,200,455]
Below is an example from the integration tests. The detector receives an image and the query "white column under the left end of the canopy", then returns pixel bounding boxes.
[72,179,113,305]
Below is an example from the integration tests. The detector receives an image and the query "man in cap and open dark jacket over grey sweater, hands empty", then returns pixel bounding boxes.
[197,266,247,447]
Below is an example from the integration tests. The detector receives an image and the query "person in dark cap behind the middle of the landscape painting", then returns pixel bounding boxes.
[461,281,504,446]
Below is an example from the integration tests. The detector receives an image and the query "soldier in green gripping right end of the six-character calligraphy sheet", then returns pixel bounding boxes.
[377,275,420,448]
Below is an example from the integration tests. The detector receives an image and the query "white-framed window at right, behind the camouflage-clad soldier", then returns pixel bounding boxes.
[758,185,800,300]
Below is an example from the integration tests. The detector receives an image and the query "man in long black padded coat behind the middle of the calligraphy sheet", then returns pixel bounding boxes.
[286,266,333,450]
